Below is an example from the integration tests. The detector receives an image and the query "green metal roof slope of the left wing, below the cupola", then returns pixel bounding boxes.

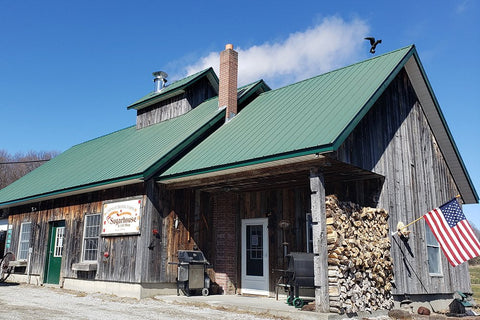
[0,98,225,207]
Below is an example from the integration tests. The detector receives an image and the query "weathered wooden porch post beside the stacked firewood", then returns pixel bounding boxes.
[310,168,330,312]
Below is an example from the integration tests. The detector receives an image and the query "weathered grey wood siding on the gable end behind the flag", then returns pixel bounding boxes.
[337,71,471,294]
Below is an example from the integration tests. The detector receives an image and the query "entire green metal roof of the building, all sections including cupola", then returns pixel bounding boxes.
[0,46,478,208]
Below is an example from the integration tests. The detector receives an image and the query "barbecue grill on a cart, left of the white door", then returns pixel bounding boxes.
[170,250,211,296]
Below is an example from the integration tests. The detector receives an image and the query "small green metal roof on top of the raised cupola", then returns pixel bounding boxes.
[127,68,218,110]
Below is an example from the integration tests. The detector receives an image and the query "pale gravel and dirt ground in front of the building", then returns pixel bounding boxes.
[0,283,480,320]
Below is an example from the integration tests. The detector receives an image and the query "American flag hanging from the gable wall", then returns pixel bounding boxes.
[424,198,480,267]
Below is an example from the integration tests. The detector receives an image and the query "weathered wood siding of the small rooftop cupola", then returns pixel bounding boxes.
[137,78,216,129]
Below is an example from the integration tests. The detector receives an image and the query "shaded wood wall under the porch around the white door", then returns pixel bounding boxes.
[166,188,310,293]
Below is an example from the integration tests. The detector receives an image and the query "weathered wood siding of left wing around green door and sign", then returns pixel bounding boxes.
[8,184,148,282]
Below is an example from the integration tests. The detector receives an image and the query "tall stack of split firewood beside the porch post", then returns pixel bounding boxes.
[326,195,393,313]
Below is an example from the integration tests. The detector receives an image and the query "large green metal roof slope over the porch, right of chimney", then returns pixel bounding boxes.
[160,46,415,180]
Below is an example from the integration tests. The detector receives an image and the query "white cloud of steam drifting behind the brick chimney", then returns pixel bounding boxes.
[182,17,369,87]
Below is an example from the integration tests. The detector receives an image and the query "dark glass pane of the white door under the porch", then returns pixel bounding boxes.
[246,225,263,277]
